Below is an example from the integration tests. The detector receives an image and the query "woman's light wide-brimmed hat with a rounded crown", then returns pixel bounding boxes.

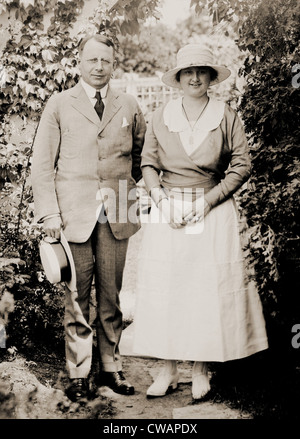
[161,44,231,88]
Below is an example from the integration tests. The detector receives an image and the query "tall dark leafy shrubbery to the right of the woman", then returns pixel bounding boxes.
[195,0,300,325]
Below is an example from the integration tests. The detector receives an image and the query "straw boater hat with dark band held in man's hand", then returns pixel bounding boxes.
[39,232,76,291]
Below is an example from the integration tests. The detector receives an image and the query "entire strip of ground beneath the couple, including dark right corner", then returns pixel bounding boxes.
[0,324,300,421]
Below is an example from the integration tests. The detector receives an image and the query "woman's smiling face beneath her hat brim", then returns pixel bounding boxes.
[179,67,210,97]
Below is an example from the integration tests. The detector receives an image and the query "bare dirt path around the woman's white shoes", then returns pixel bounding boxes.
[100,357,251,419]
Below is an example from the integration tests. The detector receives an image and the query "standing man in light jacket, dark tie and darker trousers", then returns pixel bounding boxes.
[32,35,146,400]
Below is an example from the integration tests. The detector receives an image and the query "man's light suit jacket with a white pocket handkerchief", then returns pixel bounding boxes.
[31,83,146,242]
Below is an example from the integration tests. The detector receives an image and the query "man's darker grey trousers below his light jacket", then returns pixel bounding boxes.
[65,222,128,378]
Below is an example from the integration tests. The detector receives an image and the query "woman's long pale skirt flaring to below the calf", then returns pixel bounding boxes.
[133,198,268,361]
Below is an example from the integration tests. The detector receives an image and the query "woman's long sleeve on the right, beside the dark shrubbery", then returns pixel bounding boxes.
[205,109,251,208]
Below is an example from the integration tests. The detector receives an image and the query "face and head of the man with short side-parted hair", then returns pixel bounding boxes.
[79,38,115,90]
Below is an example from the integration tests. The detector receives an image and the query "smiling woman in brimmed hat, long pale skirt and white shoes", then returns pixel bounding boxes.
[134,44,268,399]
